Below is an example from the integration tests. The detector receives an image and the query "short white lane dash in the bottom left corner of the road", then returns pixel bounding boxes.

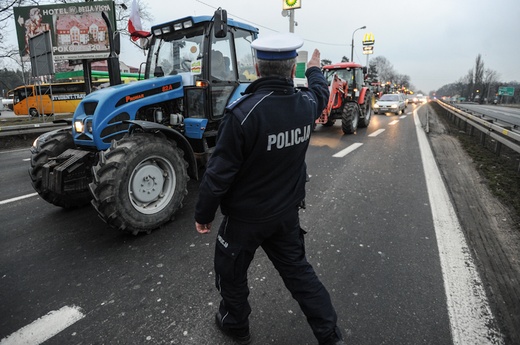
[0,306,85,345]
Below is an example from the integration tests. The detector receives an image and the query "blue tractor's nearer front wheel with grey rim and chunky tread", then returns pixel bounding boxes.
[90,133,188,235]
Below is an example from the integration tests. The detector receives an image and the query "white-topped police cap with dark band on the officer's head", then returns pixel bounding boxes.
[251,33,303,60]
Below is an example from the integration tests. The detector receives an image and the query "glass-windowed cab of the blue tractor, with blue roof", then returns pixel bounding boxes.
[145,10,258,119]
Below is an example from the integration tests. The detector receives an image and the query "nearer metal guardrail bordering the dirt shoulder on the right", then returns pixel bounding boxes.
[437,100,520,153]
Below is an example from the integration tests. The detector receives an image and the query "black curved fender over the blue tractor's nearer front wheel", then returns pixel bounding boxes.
[123,120,199,180]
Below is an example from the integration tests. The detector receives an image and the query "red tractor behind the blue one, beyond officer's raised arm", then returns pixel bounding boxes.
[316,62,373,134]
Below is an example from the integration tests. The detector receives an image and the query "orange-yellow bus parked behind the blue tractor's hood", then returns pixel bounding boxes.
[13,81,108,117]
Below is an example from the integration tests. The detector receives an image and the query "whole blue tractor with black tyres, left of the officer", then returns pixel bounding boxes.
[29,9,258,234]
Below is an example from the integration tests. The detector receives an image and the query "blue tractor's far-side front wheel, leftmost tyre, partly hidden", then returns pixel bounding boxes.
[29,130,92,209]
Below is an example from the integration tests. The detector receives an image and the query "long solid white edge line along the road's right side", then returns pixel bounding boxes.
[413,110,504,345]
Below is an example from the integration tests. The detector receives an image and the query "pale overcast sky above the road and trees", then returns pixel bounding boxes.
[7,0,520,93]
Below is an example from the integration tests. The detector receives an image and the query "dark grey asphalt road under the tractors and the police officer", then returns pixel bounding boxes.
[0,106,501,345]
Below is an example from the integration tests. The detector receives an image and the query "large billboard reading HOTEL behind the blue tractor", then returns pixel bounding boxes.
[13,1,116,61]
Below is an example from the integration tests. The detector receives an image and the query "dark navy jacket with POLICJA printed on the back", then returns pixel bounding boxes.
[195,67,329,224]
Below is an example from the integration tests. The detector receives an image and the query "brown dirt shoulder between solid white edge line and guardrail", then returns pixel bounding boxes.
[419,105,520,344]
